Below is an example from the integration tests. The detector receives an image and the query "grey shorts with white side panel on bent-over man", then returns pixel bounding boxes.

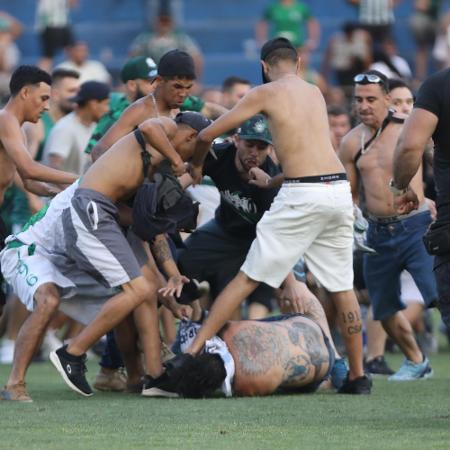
[60,188,142,287]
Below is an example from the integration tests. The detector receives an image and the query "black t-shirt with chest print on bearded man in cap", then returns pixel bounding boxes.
[203,142,280,237]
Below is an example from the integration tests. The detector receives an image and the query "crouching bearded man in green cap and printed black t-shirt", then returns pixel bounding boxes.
[179,114,280,320]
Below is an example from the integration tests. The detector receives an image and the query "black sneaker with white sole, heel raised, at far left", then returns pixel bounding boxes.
[50,345,94,397]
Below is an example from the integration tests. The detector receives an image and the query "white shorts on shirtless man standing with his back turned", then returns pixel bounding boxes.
[241,181,354,292]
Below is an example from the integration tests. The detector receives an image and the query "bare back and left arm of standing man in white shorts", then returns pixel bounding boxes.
[194,73,344,178]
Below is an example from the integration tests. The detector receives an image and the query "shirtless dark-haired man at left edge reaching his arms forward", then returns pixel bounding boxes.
[0,66,76,315]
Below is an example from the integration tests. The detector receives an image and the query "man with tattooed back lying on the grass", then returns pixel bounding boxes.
[167,288,362,398]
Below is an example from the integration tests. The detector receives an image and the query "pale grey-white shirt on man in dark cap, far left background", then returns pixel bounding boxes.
[43,111,96,175]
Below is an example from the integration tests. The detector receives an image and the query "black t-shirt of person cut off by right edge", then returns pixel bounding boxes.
[414,69,450,199]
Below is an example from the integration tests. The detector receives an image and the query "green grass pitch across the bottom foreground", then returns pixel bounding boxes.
[0,353,450,450]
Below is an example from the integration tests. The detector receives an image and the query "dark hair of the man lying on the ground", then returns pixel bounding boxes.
[176,353,227,398]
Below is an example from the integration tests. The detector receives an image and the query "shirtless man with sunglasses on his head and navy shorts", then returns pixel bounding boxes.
[340,70,437,381]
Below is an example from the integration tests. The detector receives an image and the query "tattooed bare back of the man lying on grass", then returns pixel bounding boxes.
[221,316,330,395]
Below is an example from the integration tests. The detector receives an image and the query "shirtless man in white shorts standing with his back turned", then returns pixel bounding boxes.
[188,38,371,393]
